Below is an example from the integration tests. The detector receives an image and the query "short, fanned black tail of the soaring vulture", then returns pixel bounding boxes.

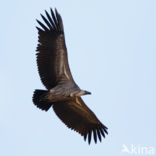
[32,90,52,111]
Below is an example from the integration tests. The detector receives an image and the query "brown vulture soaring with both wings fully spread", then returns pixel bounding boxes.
[33,8,108,144]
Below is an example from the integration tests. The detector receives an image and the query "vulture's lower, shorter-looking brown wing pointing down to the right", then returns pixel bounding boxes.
[53,97,108,144]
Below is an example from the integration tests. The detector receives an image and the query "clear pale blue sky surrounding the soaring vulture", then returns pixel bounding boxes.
[0,0,156,156]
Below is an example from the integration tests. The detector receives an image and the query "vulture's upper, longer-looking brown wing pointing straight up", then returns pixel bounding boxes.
[36,9,73,89]
